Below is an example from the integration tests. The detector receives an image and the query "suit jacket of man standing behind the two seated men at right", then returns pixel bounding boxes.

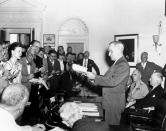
[136,62,162,85]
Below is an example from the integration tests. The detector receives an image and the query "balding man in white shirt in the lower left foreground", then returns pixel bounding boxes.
[0,84,45,131]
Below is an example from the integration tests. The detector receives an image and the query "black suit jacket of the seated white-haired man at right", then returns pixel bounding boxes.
[134,85,164,108]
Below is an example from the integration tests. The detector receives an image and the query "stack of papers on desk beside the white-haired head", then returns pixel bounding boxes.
[77,103,100,116]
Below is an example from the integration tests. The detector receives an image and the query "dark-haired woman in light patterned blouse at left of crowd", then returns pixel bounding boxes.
[4,42,22,83]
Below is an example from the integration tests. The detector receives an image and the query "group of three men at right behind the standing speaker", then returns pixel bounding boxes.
[122,52,165,125]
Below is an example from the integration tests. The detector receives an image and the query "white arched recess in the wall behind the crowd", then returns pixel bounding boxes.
[58,18,89,54]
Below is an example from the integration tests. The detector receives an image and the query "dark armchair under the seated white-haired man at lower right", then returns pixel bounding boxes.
[129,93,166,131]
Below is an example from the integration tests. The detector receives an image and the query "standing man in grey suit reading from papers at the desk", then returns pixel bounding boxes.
[87,41,130,125]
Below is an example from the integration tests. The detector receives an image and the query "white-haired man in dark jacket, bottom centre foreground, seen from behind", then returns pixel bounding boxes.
[56,102,109,131]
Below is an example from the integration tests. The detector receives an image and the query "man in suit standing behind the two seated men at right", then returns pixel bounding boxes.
[136,52,162,86]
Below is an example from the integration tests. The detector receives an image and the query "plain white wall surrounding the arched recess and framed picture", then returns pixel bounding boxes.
[42,0,166,74]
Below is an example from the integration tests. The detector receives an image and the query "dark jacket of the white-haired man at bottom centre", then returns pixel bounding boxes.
[71,118,110,131]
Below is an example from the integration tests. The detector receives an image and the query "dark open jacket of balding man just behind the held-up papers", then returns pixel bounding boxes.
[78,59,100,75]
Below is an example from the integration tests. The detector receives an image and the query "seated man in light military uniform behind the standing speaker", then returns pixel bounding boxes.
[126,69,149,106]
